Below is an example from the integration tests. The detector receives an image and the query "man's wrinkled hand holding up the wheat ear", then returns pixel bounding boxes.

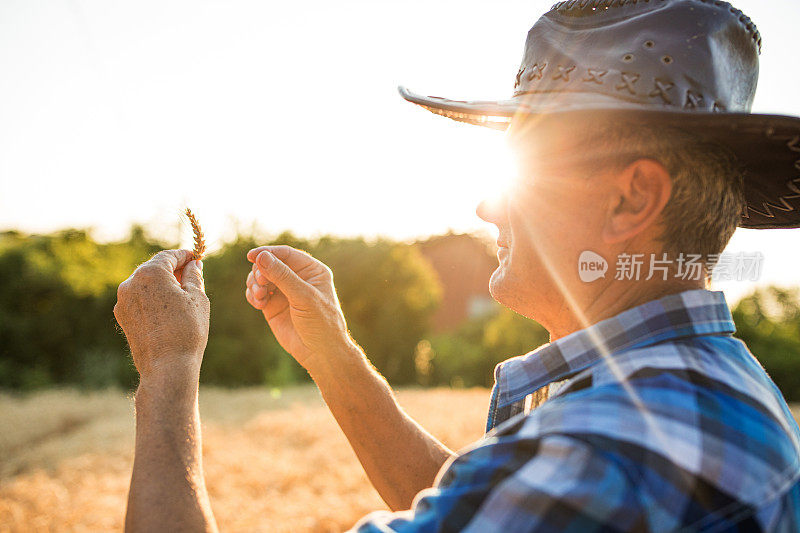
[114,250,210,379]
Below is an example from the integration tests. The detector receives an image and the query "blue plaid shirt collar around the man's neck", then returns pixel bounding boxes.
[494,289,736,408]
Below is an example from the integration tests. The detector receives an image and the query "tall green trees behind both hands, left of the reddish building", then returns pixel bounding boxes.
[0,228,440,389]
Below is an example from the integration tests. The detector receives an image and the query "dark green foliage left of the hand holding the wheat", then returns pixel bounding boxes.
[0,228,160,388]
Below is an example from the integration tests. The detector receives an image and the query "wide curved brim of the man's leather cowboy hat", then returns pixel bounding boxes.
[398,87,800,229]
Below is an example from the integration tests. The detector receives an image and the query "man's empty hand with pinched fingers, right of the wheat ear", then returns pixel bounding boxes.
[245,246,360,375]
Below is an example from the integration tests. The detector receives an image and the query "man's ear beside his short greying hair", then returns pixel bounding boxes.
[603,159,672,244]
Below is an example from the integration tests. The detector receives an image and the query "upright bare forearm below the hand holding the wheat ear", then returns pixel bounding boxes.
[125,374,217,532]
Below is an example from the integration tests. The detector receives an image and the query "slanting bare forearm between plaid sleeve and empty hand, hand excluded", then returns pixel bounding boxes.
[312,346,453,510]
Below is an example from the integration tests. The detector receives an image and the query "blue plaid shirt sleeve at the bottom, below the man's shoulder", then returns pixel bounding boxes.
[351,435,645,533]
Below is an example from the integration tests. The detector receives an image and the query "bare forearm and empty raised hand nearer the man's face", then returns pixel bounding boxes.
[247,246,453,510]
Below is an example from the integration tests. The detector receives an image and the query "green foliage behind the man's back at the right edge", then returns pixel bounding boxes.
[733,287,800,402]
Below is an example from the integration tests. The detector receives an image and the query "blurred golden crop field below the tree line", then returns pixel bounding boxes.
[0,386,489,532]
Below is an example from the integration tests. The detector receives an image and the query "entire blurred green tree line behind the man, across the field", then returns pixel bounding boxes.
[0,226,800,401]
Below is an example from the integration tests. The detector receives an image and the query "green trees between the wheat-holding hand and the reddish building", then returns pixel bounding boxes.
[202,233,440,385]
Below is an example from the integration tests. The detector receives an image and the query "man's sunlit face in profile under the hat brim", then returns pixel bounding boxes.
[478,120,607,320]
